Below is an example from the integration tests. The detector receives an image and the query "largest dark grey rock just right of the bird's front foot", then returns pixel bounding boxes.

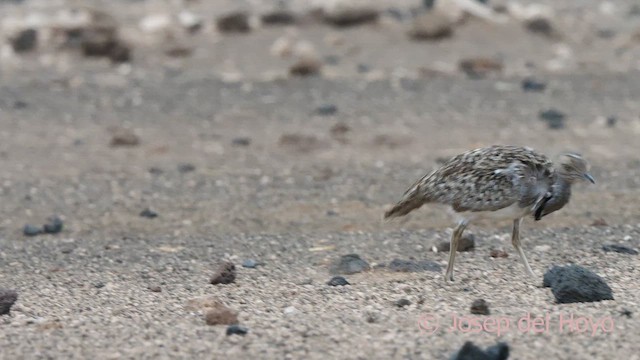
[543,265,613,304]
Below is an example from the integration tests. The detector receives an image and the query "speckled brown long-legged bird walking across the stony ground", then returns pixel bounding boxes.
[384,145,595,281]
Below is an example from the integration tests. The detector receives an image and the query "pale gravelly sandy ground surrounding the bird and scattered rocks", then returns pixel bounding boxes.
[0,1,640,359]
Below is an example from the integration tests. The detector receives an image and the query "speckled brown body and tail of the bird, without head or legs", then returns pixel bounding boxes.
[385,145,555,218]
